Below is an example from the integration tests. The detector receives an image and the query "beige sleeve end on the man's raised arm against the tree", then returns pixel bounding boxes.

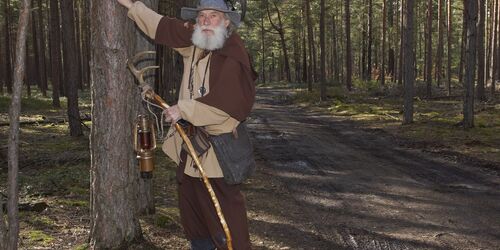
[127,1,163,39]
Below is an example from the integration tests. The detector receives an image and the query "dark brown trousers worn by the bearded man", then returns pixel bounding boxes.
[177,149,251,250]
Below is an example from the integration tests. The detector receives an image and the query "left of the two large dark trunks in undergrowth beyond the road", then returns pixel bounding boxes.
[403,0,415,124]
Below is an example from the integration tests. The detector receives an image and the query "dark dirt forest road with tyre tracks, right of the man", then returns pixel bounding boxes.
[245,89,500,250]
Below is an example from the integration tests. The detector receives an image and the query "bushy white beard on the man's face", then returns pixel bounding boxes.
[191,22,228,50]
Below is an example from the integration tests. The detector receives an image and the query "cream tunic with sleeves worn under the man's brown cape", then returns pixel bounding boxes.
[128,2,239,178]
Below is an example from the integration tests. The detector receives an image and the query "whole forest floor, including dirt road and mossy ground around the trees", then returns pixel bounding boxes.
[0,86,500,249]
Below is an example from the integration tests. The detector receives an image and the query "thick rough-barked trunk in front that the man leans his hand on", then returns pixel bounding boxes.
[90,0,142,249]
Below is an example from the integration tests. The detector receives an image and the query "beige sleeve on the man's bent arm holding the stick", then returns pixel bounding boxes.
[177,99,239,134]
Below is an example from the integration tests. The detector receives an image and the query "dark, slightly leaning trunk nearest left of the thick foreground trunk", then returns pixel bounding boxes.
[60,0,83,136]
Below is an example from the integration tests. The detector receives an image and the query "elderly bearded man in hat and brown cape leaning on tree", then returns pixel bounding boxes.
[117,0,256,249]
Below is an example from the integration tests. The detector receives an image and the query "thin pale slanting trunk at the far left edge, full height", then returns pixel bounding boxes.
[5,0,30,250]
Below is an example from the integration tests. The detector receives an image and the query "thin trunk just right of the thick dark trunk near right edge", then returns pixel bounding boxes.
[477,0,486,101]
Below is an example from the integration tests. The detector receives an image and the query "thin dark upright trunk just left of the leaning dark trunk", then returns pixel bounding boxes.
[49,0,61,108]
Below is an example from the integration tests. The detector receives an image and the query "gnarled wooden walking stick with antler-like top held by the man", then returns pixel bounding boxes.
[127,51,233,250]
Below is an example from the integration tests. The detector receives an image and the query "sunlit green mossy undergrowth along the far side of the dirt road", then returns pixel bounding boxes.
[291,84,500,166]
